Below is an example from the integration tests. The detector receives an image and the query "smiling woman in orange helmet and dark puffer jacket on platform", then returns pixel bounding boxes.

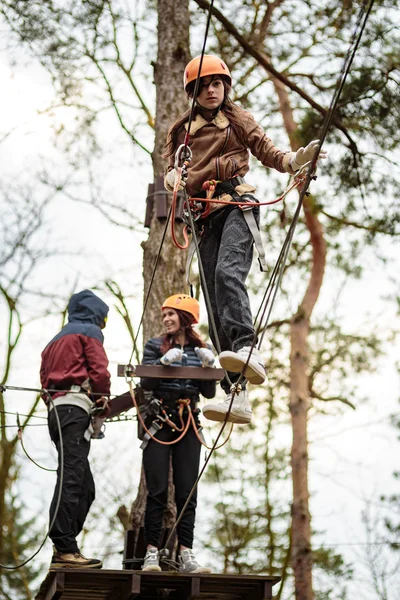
[141,294,216,573]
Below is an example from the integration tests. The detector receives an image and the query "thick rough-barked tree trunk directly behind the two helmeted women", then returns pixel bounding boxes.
[131,0,190,529]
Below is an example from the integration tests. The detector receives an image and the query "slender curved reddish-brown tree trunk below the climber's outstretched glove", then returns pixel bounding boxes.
[290,196,326,600]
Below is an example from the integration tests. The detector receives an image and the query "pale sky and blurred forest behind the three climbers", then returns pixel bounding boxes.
[0,0,400,600]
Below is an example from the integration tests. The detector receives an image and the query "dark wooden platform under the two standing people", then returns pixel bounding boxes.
[35,569,280,600]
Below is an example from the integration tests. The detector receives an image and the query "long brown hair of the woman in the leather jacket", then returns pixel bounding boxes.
[163,76,247,158]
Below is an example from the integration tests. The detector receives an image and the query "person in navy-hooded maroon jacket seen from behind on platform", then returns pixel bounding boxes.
[40,290,110,569]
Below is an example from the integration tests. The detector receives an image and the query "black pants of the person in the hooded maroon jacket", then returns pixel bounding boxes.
[48,405,95,553]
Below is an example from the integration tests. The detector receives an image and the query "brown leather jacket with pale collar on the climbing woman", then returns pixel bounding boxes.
[166,107,294,196]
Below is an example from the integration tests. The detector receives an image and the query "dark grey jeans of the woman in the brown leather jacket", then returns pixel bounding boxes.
[200,207,259,391]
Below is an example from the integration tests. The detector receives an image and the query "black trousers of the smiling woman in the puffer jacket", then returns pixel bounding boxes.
[143,425,201,548]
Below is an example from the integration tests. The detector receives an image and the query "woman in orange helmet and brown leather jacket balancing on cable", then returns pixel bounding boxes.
[164,55,326,423]
